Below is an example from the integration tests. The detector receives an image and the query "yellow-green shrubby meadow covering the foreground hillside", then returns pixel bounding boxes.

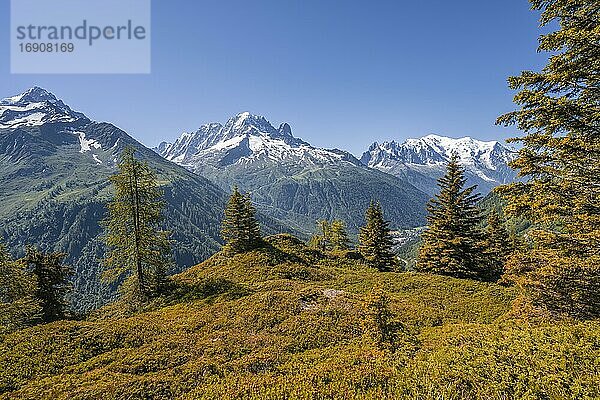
[0,235,600,399]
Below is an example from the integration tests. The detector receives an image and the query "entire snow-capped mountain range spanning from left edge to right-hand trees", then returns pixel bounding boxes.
[0,87,514,311]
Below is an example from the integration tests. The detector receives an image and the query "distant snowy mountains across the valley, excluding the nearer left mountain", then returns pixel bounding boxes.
[154,112,515,231]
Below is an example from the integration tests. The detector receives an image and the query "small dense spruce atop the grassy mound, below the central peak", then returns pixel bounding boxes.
[221,187,263,254]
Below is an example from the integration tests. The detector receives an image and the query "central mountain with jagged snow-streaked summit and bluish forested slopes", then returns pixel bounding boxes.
[155,112,428,233]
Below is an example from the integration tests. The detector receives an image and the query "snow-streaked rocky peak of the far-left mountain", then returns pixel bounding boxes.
[0,86,87,128]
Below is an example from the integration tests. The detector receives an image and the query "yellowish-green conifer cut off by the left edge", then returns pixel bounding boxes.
[0,243,41,334]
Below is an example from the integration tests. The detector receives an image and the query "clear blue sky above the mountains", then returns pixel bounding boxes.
[0,0,546,155]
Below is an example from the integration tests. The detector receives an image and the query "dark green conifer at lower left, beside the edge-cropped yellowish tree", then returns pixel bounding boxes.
[21,246,74,323]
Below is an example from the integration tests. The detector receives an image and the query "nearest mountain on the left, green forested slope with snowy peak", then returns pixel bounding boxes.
[0,87,226,311]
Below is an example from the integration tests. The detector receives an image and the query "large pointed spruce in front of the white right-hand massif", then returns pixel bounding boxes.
[416,154,486,279]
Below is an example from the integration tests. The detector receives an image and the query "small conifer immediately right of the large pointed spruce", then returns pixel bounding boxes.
[482,211,514,282]
